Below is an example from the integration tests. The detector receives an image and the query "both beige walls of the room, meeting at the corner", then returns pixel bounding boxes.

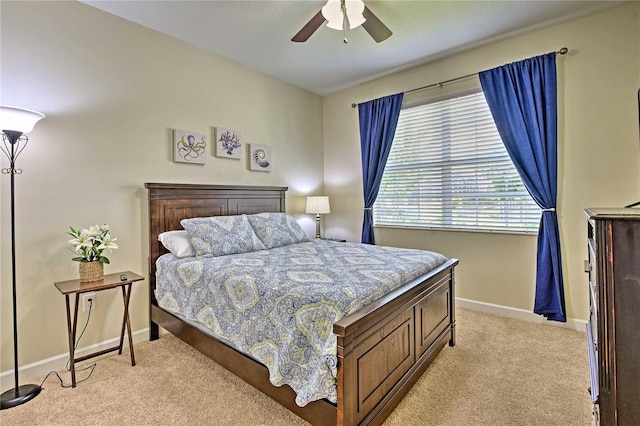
[0,2,640,371]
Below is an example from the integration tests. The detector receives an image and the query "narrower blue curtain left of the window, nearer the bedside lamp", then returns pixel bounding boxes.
[358,93,404,244]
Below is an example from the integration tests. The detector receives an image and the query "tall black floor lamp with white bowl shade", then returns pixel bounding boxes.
[0,105,44,410]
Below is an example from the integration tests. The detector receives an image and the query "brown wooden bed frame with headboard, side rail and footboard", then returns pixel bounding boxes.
[145,183,458,425]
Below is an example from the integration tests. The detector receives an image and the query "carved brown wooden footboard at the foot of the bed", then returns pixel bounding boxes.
[333,259,458,425]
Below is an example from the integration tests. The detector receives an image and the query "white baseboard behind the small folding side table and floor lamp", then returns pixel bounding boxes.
[0,327,149,389]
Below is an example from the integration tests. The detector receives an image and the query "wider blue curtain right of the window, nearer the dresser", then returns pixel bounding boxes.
[479,53,566,322]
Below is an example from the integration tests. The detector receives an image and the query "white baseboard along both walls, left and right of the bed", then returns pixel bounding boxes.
[0,297,586,389]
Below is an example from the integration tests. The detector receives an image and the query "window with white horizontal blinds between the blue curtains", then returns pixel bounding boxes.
[373,91,541,233]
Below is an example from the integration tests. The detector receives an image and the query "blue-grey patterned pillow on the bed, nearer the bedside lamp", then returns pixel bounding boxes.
[247,213,309,249]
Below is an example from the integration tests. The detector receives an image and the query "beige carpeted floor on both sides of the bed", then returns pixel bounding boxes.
[0,309,592,426]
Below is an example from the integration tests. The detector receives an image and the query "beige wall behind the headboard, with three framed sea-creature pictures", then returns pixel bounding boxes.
[0,1,323,371]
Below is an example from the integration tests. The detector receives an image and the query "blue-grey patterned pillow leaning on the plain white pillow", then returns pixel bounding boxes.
[180,214,265,257]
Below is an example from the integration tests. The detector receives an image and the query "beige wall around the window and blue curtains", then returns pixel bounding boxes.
[323,2,640,320]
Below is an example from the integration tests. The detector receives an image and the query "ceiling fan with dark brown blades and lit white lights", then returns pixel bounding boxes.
[291,0,393,43]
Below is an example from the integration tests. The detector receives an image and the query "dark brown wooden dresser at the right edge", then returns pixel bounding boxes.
[585,208,640,426]
